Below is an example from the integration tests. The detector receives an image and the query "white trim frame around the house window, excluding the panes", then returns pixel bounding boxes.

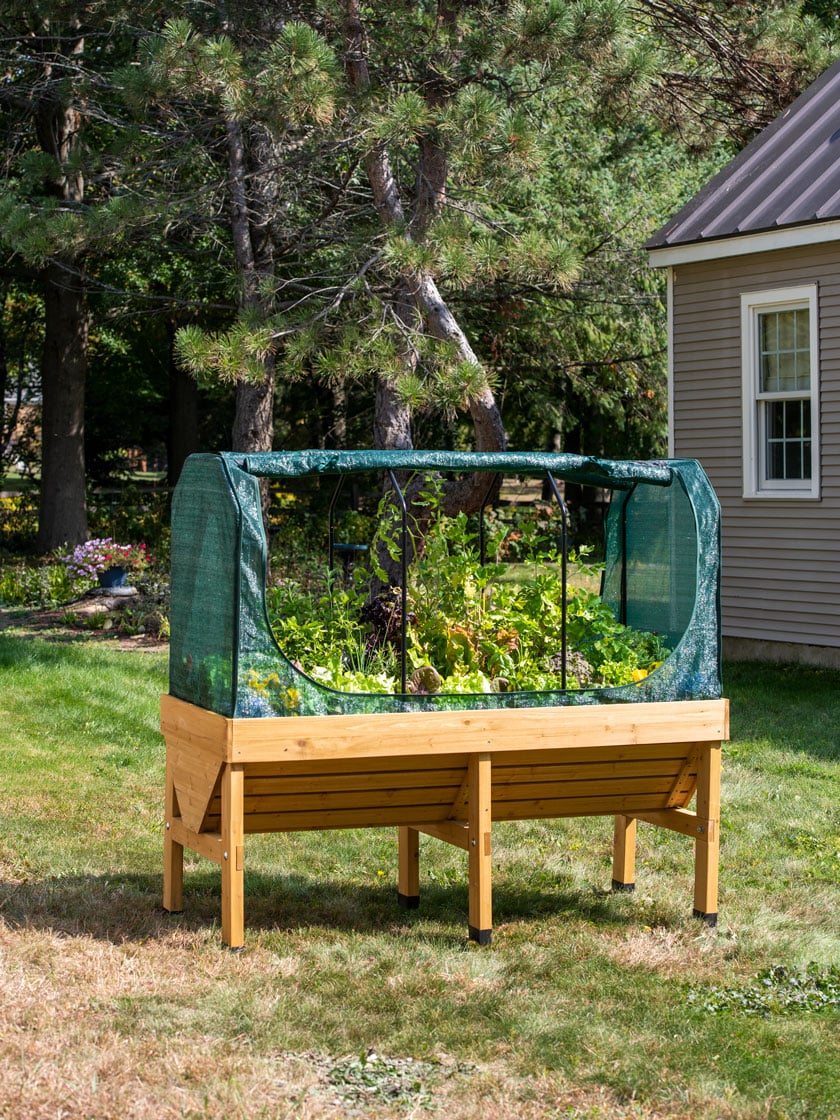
[740,284,820,501]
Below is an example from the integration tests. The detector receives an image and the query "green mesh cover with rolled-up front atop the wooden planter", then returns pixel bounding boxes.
[169,451,720,717]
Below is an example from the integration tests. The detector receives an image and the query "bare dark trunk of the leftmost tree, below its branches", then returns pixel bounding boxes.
[38,262,87,552]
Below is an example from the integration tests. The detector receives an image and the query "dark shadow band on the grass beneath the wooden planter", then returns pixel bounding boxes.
[0,869,649,944]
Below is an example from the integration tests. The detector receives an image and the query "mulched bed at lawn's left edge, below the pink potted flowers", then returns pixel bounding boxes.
[0,589,169,652]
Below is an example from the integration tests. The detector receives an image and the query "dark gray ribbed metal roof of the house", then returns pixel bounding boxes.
[645,59,840,249]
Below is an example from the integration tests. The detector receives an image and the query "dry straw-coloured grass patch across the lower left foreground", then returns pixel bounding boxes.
[0,921,725,1120]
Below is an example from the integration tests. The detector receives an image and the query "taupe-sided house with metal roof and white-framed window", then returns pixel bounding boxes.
[645,60,840,666]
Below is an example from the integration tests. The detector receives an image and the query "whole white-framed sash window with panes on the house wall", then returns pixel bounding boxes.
[741,284,820,498]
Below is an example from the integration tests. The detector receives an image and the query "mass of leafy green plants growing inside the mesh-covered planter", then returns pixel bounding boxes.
[269,506,668,693]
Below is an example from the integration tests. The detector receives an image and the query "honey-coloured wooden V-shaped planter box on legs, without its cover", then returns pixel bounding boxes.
[161,696,729,949]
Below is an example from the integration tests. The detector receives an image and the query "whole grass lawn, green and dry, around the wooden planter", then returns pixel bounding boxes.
[0,633,840,1120]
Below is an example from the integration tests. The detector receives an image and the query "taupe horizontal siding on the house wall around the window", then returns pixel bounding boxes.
[673,244,840,647]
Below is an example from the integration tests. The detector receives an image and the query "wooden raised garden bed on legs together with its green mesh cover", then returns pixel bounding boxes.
[161,451,728,946]
